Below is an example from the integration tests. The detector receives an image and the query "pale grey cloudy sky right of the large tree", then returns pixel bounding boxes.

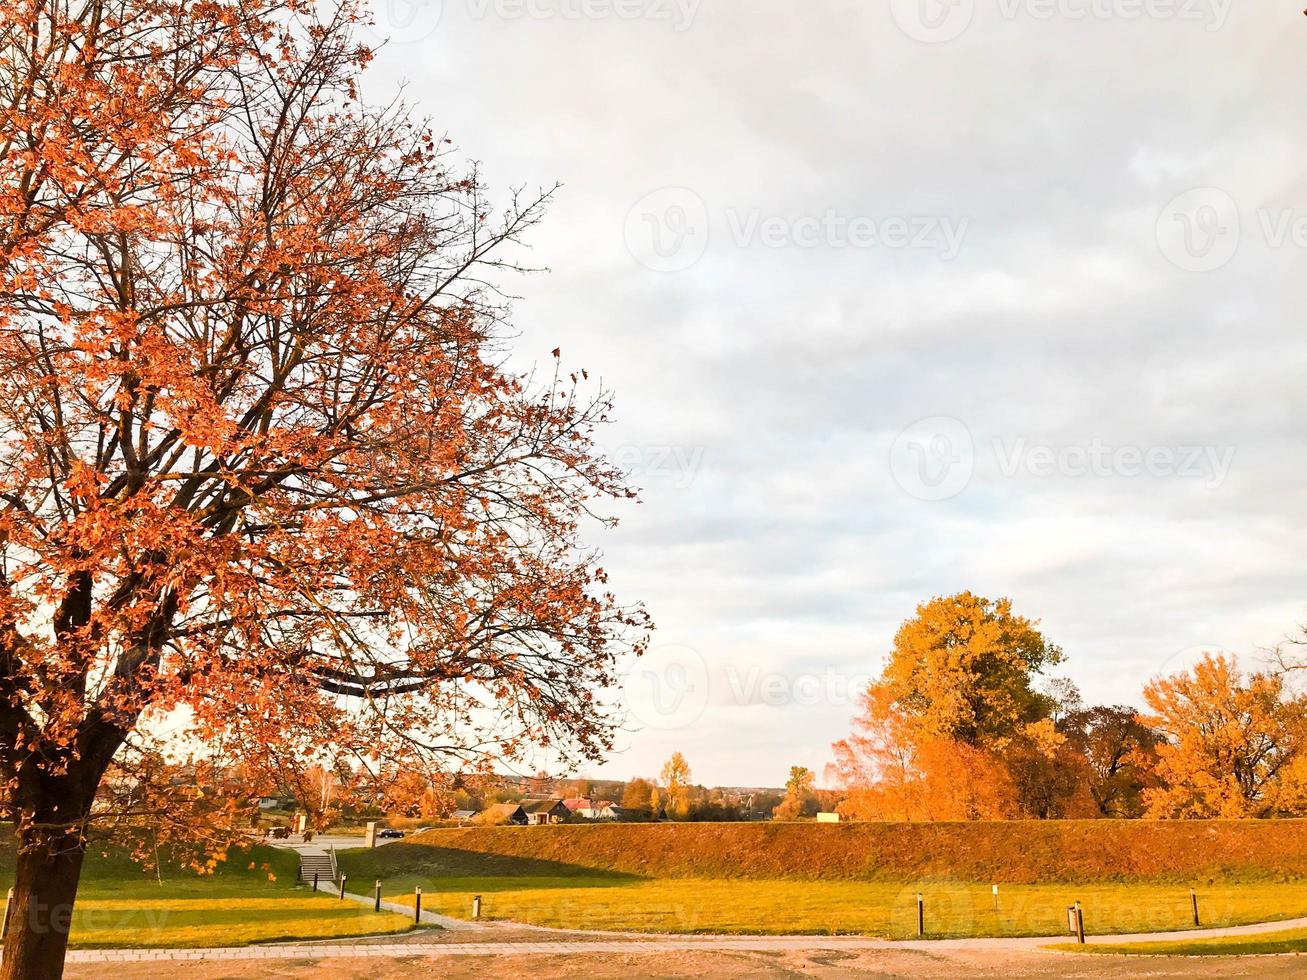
[369,0,1307,785]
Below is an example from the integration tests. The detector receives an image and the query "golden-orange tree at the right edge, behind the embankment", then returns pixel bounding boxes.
[1144,653,1307,818]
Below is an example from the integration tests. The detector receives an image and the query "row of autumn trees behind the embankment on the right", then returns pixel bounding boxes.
[827,592,1307,821]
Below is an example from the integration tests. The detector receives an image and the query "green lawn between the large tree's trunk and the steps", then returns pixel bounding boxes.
[0,847,412,949]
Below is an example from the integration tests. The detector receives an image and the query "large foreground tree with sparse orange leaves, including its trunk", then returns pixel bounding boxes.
[0,0,646,977]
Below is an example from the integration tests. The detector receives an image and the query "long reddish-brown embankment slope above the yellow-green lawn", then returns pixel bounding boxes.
[352,821,1307,885]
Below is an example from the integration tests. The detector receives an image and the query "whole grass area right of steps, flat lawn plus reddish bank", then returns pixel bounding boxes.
[341,822,1307,938]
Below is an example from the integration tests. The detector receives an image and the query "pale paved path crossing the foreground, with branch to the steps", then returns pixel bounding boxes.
[68,914,1307,963]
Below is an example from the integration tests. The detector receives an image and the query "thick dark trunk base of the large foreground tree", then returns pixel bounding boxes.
[0,835,86,980]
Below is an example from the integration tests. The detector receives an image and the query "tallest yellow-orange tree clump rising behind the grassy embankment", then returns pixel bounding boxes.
[829,592,1091,821]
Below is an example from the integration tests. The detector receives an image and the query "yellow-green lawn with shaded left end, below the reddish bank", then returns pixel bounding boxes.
[340,846,1307,938]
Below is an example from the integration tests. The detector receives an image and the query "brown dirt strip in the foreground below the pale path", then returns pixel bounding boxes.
[65,950,1307,980]
